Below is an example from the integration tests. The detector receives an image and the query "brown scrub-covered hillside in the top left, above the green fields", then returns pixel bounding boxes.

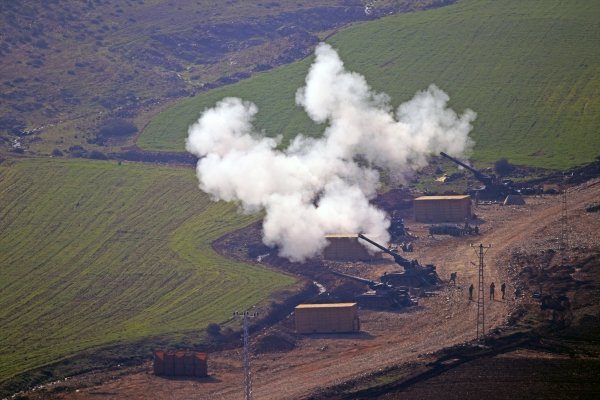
[0,0,452,158]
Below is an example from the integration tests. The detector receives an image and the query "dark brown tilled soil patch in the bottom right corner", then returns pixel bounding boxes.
[377,350,600,400]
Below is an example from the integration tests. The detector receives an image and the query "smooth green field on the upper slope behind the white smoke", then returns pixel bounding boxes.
[138,0,600,168]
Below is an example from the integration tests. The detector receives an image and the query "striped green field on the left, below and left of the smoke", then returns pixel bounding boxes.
[0,160,294,382]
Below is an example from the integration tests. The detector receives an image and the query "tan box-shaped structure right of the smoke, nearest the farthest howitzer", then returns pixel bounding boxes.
[414,195,471,222]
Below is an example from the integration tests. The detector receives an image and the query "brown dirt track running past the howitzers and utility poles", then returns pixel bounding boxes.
[30,180,600,400]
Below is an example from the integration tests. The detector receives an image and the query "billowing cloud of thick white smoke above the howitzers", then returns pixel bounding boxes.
[186,43,476,261]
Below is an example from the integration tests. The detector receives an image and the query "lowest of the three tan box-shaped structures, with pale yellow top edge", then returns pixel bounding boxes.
[294,303,360,333]
